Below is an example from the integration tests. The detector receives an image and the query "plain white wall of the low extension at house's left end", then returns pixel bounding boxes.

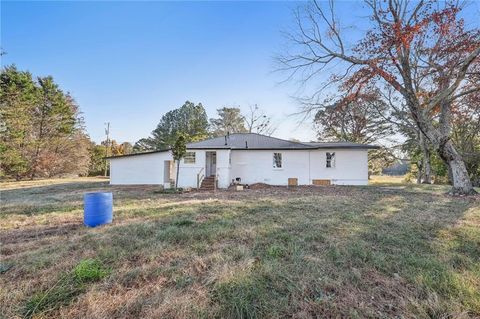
[110,152,172,185]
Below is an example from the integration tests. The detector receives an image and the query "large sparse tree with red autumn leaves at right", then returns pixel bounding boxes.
[279,0,480,194]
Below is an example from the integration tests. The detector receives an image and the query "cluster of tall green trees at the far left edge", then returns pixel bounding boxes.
[0,66,90,179]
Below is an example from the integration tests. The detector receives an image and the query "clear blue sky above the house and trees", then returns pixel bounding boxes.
[1,1,479,142]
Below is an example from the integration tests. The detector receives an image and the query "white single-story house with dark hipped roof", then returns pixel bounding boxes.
[108,133,378,188]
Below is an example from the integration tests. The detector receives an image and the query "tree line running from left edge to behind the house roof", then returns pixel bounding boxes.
[0,66,274,180]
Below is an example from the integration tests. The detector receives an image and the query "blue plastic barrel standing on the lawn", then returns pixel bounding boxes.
[83,193,113,227]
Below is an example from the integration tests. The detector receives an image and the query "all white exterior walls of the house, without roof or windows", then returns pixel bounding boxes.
[110,149,368,188]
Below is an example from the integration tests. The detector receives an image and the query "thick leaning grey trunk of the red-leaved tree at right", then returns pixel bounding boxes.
[438,141,477,195]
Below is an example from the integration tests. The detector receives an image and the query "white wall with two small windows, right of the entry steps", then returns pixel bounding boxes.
[230,149,368,185]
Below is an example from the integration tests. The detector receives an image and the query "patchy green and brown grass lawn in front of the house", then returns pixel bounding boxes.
[0,179,480,318]
